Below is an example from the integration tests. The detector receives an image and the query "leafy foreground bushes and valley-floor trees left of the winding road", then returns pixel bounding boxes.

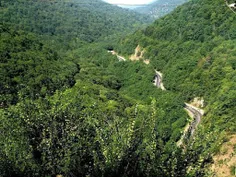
[0,31,187,176]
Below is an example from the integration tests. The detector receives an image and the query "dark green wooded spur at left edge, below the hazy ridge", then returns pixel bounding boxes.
[0,26,79,107]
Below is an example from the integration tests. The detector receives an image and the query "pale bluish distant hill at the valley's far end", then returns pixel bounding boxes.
[134,0,188,18]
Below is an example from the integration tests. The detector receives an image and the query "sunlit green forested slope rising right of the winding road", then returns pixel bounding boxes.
[118,0,236,176]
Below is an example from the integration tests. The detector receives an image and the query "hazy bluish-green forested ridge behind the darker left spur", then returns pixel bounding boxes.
[0,0,150,42]
